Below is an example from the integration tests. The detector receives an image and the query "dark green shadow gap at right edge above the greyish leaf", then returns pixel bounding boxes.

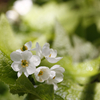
[75,19,100,42]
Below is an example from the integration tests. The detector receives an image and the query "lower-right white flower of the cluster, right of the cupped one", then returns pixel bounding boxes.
[46,65,65,90]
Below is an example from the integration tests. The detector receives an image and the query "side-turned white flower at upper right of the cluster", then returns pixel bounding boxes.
[32,43,62,63]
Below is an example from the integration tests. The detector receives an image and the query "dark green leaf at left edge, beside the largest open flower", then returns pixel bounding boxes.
[0,51,17,85]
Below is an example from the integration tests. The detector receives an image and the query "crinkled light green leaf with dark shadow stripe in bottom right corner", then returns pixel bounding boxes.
[55,79,100,100]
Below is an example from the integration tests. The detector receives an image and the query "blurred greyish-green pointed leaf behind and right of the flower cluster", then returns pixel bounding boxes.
[53,21,99,62]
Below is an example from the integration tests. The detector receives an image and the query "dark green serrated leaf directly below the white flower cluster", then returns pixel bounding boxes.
[10,74,53,100]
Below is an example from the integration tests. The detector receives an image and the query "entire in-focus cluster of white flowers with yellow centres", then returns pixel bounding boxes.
[10,41,65,90]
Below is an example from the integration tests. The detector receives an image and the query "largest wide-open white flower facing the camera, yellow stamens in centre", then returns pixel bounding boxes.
[10,51,41,77]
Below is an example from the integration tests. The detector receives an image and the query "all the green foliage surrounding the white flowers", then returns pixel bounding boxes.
[0,0,100,100]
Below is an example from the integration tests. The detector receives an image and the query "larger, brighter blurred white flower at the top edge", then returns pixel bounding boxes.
[13,0,33,15]
